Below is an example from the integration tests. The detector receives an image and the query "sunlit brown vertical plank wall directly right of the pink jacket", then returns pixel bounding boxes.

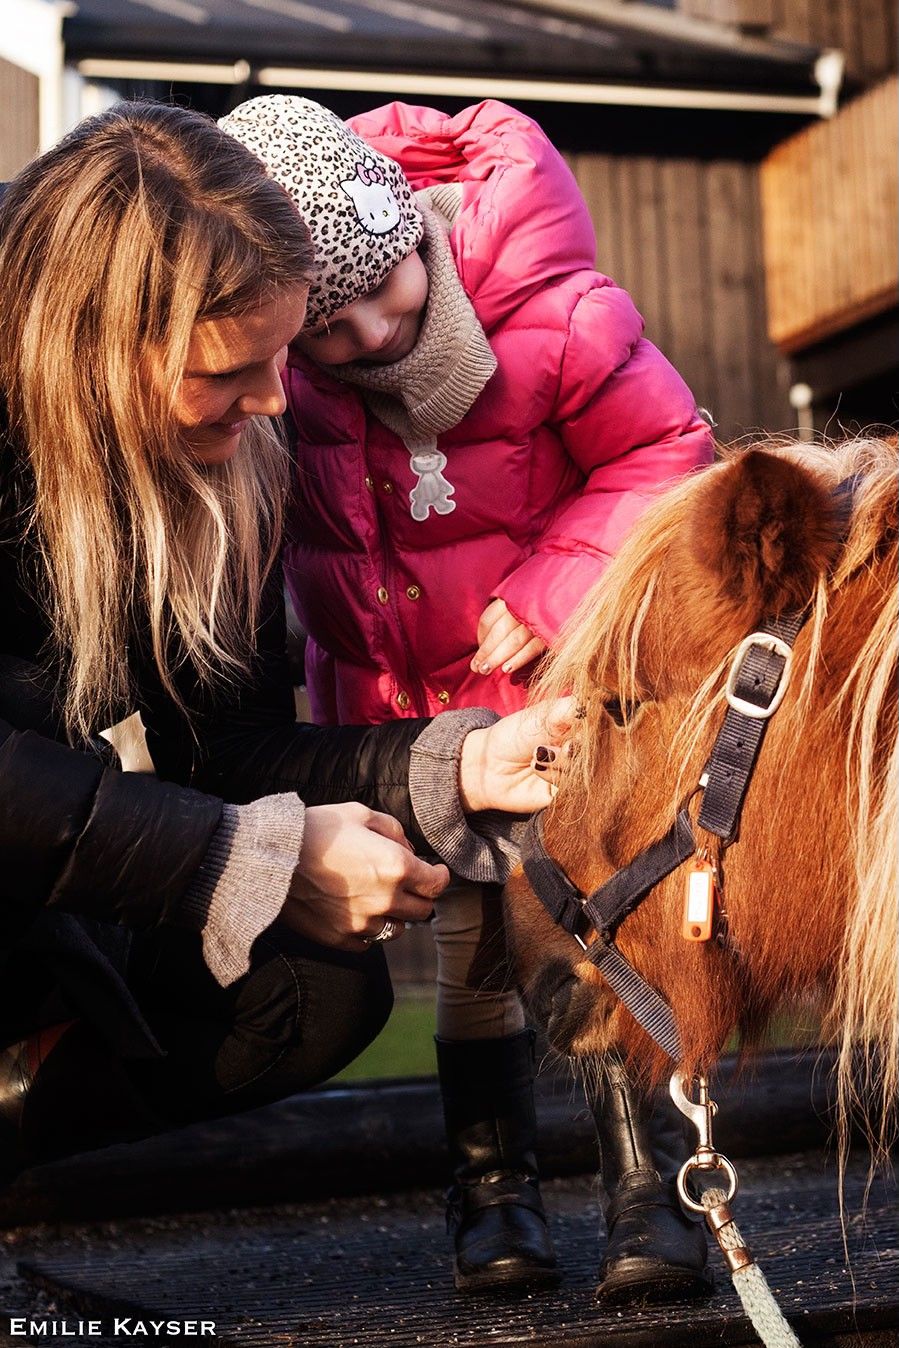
[569,154,793,439]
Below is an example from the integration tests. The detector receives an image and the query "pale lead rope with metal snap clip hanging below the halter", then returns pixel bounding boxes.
[670,1073,802,1348]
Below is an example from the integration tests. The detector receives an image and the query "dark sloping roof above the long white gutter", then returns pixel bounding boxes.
[63,0,818,94]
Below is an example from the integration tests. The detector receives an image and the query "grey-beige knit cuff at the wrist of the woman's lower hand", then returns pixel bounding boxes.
[179,793,305,987]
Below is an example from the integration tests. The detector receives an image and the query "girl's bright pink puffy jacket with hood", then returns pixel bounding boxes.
[284,100,712,724]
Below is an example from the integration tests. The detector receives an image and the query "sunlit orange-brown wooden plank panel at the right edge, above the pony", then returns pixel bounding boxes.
[762,77,899,350]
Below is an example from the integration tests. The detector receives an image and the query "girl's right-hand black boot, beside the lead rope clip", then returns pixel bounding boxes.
[593,1055,712,1306]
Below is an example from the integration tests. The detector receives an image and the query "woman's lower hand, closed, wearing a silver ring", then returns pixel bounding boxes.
[280,802,449,950]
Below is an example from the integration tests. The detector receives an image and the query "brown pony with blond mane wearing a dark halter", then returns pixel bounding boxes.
[505,439,899,1146]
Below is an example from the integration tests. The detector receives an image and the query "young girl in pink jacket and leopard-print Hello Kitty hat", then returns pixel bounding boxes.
[222,96,712,1290]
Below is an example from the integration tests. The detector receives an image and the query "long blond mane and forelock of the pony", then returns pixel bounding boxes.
[534,438,899,1154]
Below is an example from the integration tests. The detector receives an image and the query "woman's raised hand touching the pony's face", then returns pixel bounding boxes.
[460,697,574,814]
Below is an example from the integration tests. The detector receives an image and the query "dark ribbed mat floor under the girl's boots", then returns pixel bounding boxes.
[8,1153,899,1348]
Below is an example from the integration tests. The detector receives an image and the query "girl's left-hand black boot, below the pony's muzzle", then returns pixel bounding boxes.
[435,1030,559,1291]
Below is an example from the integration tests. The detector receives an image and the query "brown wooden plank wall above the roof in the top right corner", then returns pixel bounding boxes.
[678,0,899,82]
